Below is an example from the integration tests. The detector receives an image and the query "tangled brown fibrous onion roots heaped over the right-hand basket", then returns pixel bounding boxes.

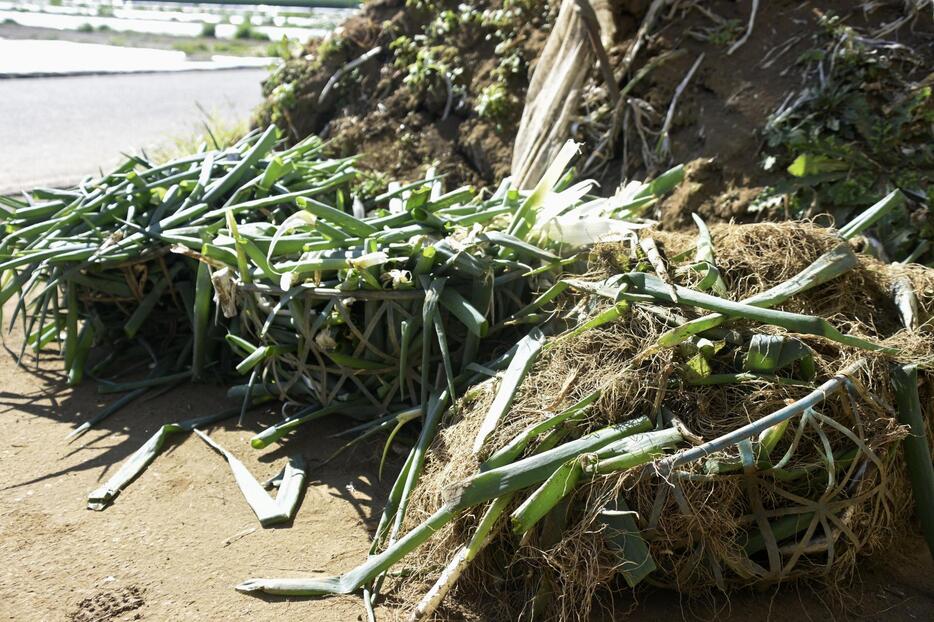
[395,223,934,620]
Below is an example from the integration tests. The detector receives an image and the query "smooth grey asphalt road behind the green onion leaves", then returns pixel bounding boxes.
[0,69,268,194]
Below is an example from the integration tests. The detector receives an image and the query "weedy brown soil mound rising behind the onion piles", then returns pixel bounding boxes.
[260,0,934,259]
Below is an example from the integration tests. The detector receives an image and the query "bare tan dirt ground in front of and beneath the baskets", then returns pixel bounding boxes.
[0,326,934,622]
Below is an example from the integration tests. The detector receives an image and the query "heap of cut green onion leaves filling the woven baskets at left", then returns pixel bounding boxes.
[0,127,682,510]
